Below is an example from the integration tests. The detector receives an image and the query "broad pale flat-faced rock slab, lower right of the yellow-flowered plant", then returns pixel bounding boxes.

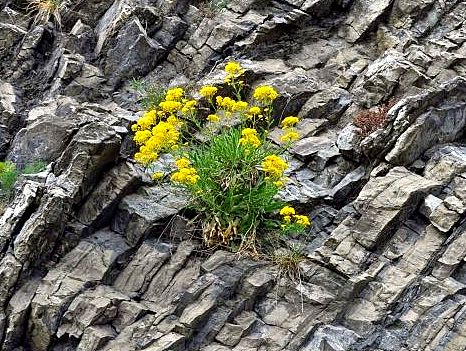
[313,167,439,275]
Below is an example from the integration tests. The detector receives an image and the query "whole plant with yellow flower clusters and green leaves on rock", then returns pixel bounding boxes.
[132,62,310,251]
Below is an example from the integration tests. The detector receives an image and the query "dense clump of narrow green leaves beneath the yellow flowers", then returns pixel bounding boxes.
[189,128,283,249]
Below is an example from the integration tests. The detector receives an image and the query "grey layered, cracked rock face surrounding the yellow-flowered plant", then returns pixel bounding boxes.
[0,0,466,351]
